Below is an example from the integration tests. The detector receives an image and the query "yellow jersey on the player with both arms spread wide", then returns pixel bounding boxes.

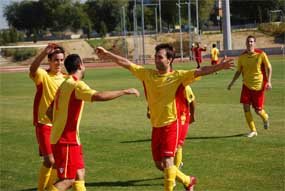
[130,64,195,127]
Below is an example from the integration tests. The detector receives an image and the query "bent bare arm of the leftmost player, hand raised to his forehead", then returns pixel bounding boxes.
[30,43,57,77]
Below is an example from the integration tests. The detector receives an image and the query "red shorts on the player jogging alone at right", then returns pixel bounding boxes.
[240,85,264,110]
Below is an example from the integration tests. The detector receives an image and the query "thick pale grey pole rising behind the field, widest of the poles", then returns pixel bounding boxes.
[223,0,232,50]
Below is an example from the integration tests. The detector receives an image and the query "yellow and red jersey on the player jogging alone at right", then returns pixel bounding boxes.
[237,49,271,90]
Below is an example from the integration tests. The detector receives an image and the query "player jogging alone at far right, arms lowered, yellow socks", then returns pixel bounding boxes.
[228,36,272,137]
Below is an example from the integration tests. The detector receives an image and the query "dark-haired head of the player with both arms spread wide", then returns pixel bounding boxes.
[155,44,175,71]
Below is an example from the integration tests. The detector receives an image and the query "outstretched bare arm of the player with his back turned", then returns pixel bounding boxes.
[92,88,140,101]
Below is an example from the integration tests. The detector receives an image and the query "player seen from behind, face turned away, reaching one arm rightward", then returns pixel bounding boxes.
[49,54,139,191]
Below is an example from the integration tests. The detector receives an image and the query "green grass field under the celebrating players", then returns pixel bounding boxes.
[0,57,285,191]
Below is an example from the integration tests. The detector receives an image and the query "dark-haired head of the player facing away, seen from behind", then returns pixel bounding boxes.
[64,54,85,78]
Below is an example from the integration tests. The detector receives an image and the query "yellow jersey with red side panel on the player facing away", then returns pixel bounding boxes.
[51,76,96,145]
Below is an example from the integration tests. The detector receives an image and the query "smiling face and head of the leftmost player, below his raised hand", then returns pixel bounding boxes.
[48,45,65,73]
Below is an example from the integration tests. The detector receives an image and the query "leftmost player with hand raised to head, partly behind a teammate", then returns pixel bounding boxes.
[30,44,65,191]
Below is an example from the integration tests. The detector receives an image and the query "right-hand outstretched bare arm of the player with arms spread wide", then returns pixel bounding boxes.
[194,58,234,77]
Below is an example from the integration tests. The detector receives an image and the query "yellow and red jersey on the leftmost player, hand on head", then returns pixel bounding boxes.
[30,68,64,126]
